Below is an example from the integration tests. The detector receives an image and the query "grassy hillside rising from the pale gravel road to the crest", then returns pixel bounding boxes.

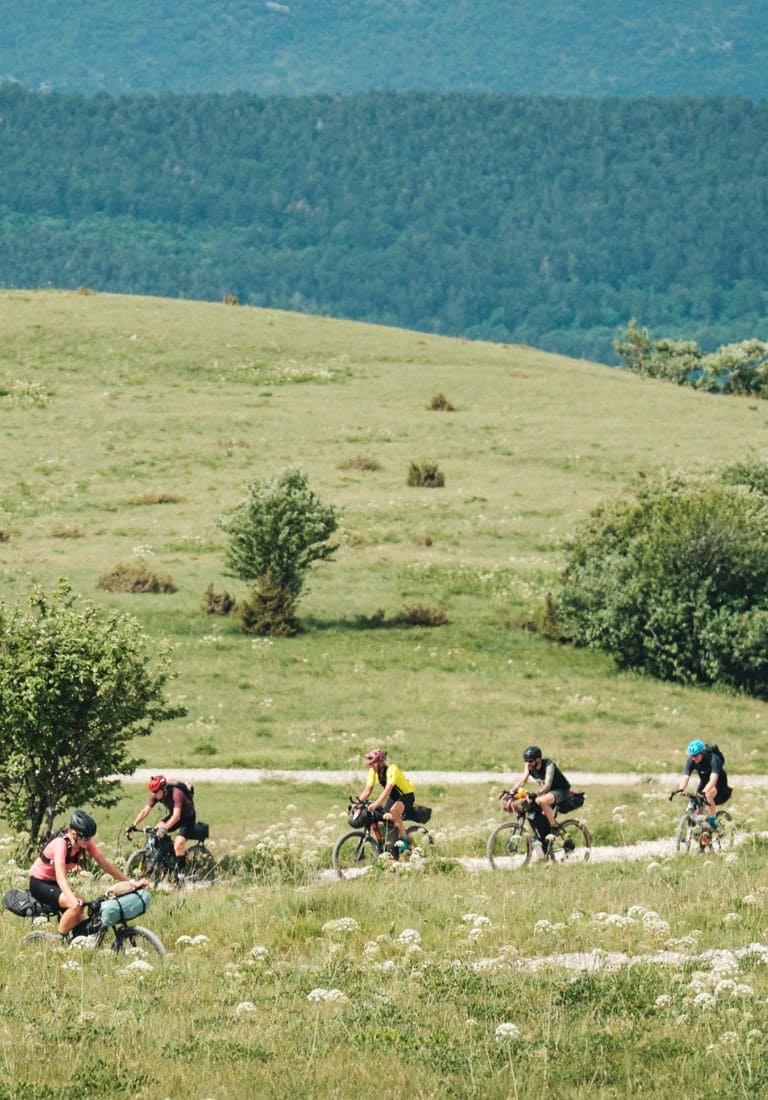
[0,293,768,772]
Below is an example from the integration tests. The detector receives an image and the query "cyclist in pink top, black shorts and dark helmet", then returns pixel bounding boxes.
[30,810,147,936]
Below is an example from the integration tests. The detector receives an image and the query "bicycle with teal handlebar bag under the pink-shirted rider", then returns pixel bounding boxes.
[2,890,166,956]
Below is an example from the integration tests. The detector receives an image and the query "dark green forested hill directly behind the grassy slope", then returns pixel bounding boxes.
[0,88,768,362]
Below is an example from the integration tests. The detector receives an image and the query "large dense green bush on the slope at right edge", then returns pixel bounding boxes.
[550,475,768,699]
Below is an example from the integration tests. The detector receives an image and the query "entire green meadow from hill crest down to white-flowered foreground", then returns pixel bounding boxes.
[0,292,768,1100]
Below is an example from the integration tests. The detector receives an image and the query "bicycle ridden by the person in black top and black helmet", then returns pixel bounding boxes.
[485,791,592,870]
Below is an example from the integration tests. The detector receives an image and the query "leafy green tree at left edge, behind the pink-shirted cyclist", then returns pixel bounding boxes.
[0,580,185,851]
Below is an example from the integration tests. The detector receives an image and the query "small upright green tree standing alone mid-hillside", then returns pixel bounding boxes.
[219,466,339,634]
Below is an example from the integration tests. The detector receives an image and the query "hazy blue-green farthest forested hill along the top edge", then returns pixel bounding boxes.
[5,0,768,99]
